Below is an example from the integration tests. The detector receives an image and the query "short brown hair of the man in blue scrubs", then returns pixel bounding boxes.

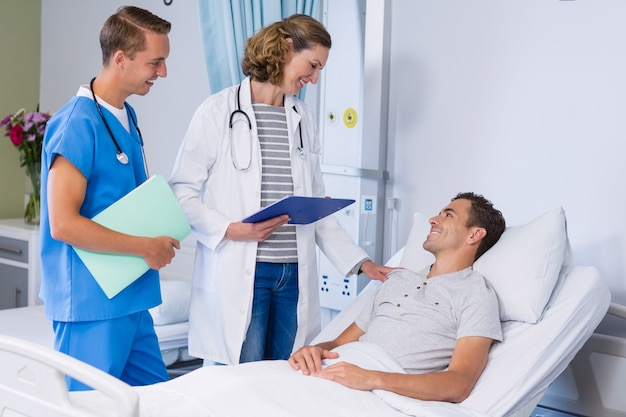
[100,6,172,65]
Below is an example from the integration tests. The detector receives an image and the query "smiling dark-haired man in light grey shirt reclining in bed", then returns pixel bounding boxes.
[289,193,505,402]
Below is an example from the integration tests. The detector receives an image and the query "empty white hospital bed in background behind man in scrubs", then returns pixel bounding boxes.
[0,242,199,374]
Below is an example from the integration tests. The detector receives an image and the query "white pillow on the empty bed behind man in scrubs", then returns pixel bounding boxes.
[149,279,191,326]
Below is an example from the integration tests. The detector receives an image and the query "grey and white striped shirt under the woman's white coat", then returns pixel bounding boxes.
[252,103,298,263]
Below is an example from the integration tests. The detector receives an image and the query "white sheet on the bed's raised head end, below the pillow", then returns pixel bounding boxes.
[462,266,611,416]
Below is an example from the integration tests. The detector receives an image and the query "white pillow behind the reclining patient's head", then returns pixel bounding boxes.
[400,207,569,323]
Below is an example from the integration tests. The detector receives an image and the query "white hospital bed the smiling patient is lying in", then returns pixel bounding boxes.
[0,209,610,417]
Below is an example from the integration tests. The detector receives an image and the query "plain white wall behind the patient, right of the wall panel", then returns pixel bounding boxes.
[388,0,626,303]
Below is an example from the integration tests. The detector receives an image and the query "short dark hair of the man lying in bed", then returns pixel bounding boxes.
[452,192,506,261]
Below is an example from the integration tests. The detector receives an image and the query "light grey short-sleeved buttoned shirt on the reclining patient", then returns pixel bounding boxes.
[355,267,502,374]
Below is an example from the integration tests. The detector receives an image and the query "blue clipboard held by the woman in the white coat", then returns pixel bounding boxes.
[243,195,355,224]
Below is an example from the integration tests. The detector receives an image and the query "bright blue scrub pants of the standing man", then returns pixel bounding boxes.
[52,311,169,391]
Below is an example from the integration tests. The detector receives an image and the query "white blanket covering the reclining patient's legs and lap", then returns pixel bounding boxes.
[127,342,484,417]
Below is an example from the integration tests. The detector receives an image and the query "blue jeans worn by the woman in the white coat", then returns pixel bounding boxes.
[239,262,298,363]
